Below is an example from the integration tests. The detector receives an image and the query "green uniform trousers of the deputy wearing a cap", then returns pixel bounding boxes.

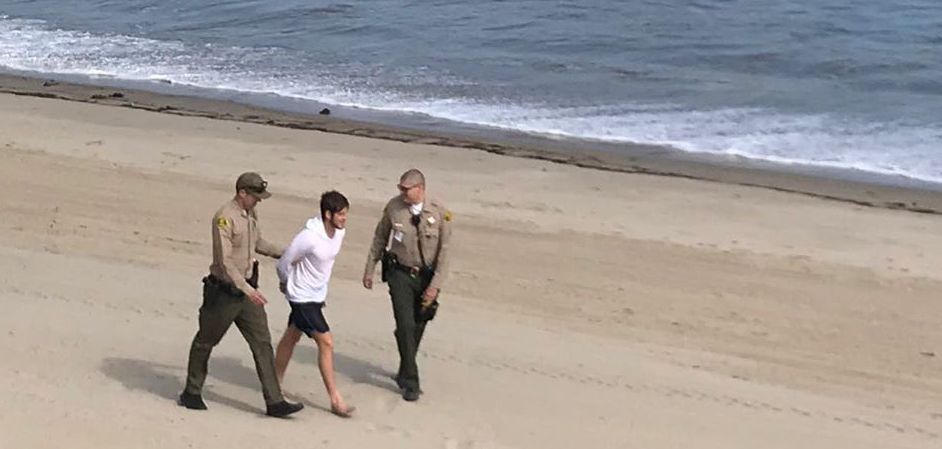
[186,282,284,405]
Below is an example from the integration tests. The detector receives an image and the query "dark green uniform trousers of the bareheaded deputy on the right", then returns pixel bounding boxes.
[386,269,432,389]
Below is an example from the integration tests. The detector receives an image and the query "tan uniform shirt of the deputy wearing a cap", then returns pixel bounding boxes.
[209,200,284,294]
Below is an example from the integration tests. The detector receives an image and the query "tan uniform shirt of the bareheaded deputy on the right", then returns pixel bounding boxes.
[364,196,451,288]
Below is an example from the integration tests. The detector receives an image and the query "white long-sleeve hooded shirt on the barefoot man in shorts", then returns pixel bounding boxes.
[277,217,344,302]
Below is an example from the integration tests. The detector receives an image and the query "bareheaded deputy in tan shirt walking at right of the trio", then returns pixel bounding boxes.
[363,169,452,401]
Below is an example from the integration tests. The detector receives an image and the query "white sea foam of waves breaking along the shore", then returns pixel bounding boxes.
[0,17,942,182]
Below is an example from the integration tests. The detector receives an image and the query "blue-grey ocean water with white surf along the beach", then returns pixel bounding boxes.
[0,0,942,183]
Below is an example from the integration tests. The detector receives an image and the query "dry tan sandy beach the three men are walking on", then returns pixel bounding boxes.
[0,86,942,449]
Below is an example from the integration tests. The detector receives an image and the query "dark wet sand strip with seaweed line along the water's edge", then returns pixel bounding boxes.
[0,74,942,215]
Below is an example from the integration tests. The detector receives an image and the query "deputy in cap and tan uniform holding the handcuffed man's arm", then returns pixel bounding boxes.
[180,172,304,417]
